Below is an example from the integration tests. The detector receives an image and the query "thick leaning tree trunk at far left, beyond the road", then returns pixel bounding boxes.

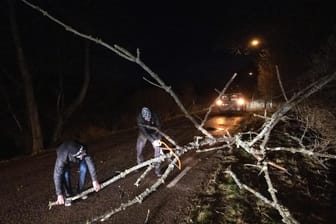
[7,0,43,155]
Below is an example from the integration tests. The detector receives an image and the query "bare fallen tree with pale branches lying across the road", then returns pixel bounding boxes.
[21,0,336,223]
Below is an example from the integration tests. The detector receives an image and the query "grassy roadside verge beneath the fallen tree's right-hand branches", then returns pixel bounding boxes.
[187,109,336,224]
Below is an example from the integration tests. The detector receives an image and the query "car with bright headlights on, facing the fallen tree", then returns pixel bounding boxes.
[215,93,247,112]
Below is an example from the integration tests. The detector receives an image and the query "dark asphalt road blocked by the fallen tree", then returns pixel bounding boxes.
[0,116,247,224]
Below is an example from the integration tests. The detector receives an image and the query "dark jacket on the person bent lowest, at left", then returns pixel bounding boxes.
[54,141,97,195]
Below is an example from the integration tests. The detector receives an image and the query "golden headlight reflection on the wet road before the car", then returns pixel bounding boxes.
[205,116,242,135]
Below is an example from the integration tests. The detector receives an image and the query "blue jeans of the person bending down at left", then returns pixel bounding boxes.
[62,159,88,197]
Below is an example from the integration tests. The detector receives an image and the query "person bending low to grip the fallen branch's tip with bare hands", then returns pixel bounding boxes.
[54,141,100,206]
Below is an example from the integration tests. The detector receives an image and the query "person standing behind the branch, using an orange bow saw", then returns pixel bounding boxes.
[136,107,161,176]
